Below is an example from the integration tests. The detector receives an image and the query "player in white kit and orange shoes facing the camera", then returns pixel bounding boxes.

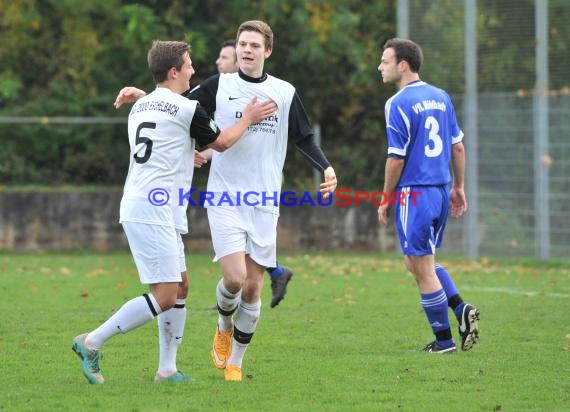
[115,20,337,381]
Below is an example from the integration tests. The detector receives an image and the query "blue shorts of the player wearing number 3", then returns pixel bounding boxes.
[393,186,449,256]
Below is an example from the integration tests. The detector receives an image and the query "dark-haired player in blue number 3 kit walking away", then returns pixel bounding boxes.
[378,38,479,354]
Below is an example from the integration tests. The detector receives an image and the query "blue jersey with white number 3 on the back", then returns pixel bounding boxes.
[385,80,463,186]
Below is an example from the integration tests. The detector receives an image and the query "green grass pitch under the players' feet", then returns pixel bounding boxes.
[0,253,570,412]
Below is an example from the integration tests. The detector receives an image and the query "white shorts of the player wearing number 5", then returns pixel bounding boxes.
[122,222,186,284]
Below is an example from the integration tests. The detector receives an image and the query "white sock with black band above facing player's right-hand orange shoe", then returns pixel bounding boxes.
[228,301,261,368]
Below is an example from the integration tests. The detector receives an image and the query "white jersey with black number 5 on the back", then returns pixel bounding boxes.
[120,87,220,233]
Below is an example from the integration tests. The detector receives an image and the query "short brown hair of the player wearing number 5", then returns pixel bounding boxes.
[147,40,191,84]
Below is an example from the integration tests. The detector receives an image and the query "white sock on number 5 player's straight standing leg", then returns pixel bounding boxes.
[156,299,186,376]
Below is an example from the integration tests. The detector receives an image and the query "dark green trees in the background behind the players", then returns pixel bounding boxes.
[0,0,570,190]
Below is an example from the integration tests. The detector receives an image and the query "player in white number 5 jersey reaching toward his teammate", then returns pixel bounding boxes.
[72,41,276,384]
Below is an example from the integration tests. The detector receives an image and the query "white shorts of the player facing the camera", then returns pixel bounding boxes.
[207,206,279,267]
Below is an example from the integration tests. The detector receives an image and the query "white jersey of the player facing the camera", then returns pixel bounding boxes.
[191,73,295,214]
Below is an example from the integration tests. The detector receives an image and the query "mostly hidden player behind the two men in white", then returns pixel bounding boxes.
[202,40,293,308]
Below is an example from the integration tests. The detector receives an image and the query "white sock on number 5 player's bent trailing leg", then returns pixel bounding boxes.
[85,293,161,350]
